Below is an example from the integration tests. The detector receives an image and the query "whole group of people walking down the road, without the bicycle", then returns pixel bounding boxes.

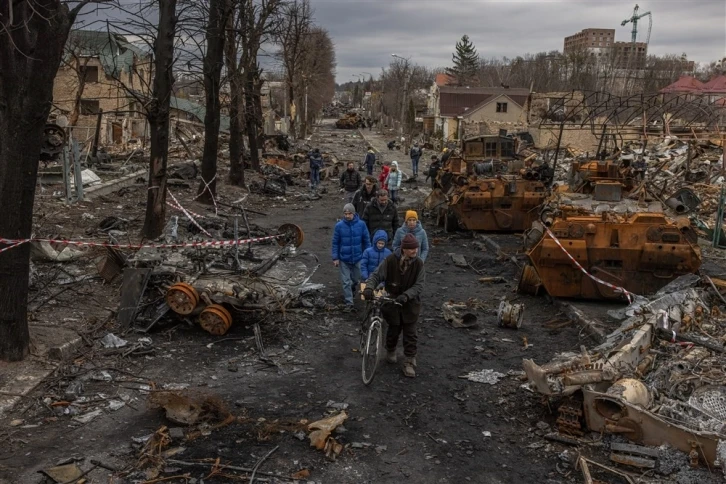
[309,144,438,377]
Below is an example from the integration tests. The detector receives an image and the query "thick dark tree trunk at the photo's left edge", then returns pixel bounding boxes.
[0,0,74,361]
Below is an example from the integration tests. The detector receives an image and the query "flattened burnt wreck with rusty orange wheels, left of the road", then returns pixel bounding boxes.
[118,224,321,335]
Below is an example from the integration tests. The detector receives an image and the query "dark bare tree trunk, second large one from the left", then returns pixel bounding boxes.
[142,0,177,239]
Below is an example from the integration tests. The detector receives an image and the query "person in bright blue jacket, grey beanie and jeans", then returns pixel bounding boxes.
[331,203,371,312]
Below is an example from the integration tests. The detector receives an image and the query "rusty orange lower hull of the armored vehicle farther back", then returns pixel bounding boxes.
[440,178,547,232]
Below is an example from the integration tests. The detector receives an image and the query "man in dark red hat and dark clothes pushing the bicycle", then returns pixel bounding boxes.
[363,234,426,378]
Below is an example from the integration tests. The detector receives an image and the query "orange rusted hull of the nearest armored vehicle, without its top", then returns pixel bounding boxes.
[519,213,701,299]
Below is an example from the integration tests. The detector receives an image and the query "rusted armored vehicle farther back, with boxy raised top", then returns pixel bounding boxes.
[425,136,553,232]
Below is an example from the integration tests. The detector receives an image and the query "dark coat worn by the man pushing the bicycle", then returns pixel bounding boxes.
[366,250,426,324]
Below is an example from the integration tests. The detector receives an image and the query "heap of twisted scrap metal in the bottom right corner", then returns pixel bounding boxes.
[523,274,726,478]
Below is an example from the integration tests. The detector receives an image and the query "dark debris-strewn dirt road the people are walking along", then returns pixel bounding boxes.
[0,122,596,483]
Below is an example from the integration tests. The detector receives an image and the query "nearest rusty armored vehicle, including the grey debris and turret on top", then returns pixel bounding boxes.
[519,180,701,299]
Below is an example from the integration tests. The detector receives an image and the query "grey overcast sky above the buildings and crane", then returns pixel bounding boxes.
[311,0,726,83]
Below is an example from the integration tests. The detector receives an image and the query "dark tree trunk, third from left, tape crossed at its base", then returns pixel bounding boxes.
[197,0,227,203]
